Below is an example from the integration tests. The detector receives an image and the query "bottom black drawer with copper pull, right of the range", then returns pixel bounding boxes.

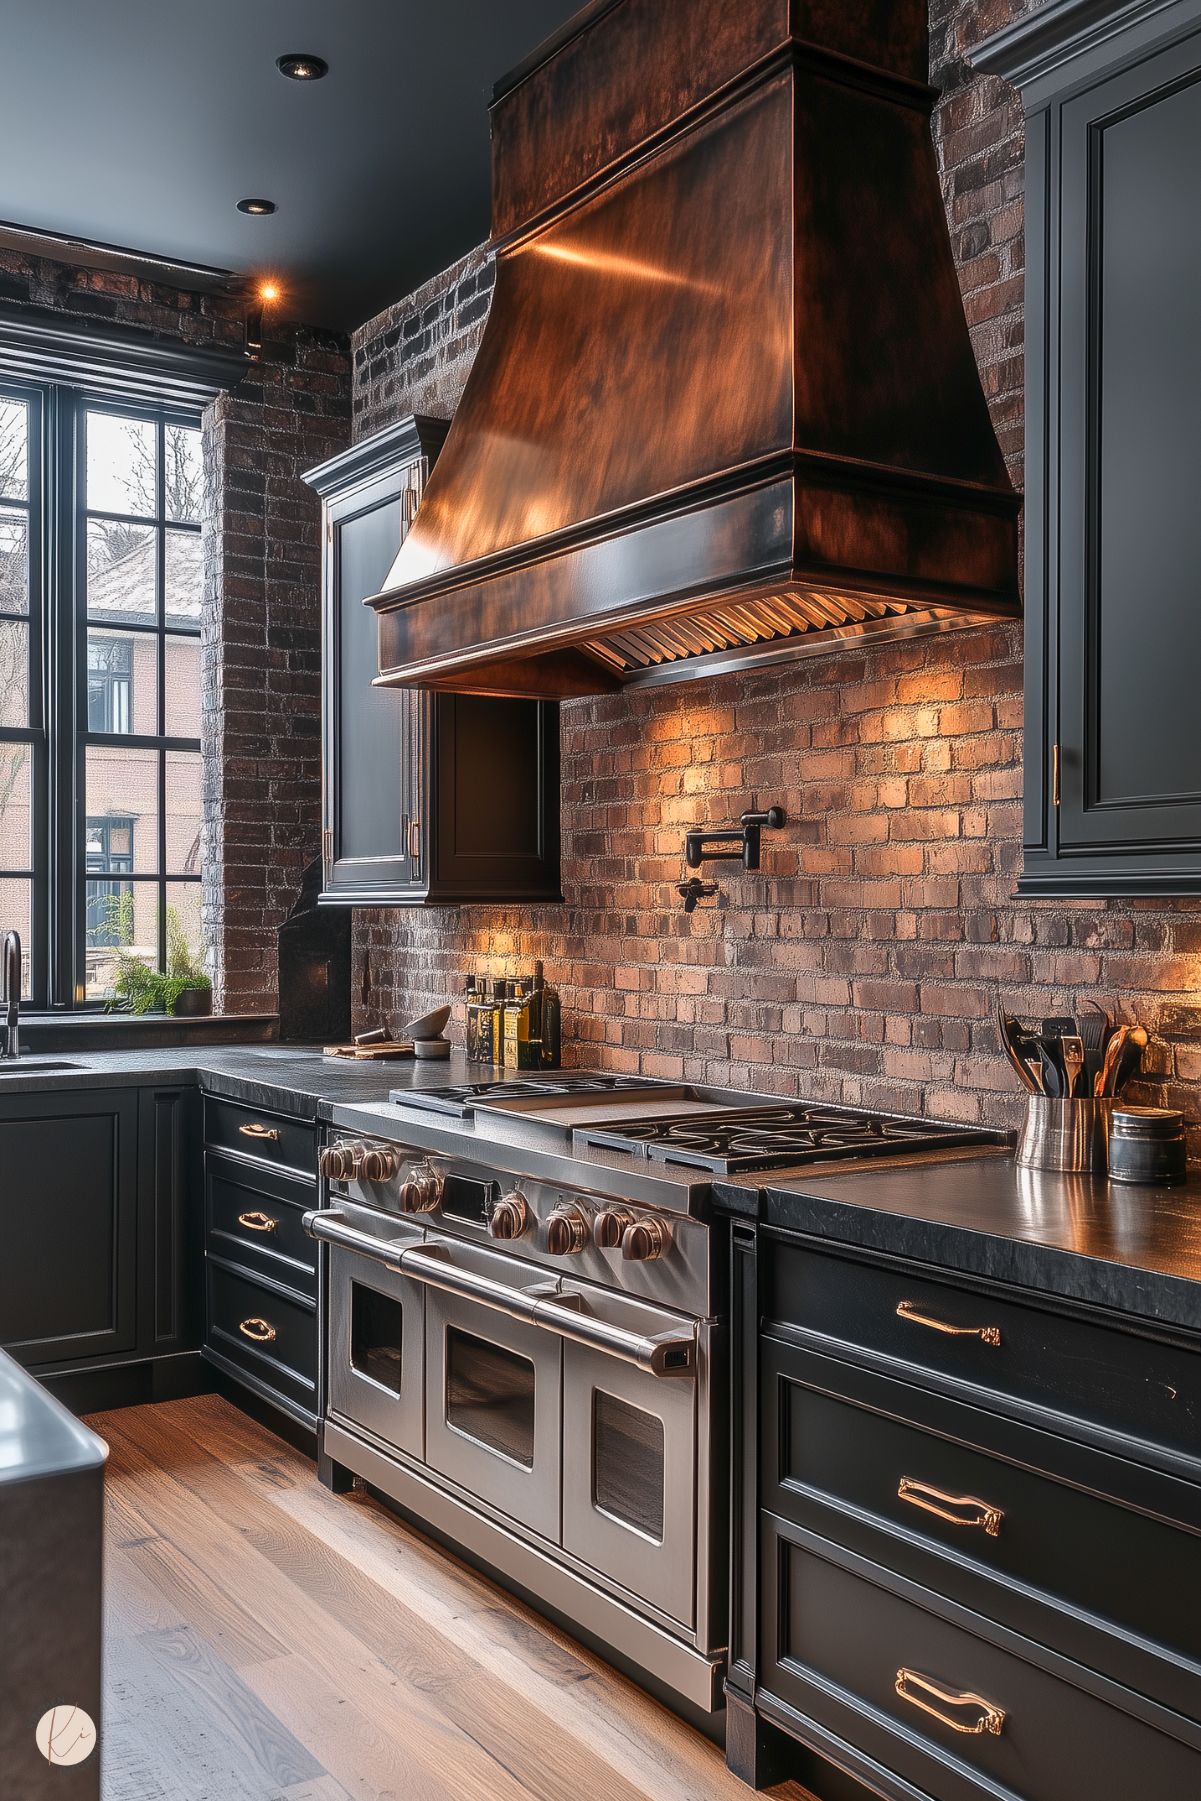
[760,1515,1201,1801]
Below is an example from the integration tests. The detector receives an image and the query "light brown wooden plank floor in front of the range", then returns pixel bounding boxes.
[90,1396,803,1801]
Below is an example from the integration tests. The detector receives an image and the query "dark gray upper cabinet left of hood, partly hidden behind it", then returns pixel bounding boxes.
[306,418,562,906]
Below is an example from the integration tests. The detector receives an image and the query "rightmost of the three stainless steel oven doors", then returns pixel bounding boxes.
[562,1297,699,1628]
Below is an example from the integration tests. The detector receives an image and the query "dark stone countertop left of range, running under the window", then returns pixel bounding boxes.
[0,1045,490,1120]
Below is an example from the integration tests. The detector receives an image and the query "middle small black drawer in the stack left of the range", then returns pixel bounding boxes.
[203,1151,317,1295]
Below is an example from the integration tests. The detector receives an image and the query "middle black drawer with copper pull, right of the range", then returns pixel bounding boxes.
[760,1338,1201,1720]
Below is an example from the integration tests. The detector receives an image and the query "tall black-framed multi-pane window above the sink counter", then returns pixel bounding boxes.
[0,387,203,1007]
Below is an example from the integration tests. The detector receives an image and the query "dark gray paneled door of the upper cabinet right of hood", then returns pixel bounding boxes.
[1059,40,1201,864]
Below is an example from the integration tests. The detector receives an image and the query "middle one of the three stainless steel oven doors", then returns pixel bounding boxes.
[425,1243,562,1543]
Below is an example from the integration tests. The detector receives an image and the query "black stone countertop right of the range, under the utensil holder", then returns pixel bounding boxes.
[717,1151,1201,1331]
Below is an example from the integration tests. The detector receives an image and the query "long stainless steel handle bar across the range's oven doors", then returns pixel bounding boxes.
[303,1210,697,1376]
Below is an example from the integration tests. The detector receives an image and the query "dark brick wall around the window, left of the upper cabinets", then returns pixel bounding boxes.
[0,250,349,1012]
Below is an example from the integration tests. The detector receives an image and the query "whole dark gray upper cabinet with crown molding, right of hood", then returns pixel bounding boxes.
[972,0,1201,897]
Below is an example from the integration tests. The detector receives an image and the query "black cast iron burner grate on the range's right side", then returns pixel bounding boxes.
[574,1102,992,1176]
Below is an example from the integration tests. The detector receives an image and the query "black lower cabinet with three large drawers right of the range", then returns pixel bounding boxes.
[727,1223,1201,1801]
